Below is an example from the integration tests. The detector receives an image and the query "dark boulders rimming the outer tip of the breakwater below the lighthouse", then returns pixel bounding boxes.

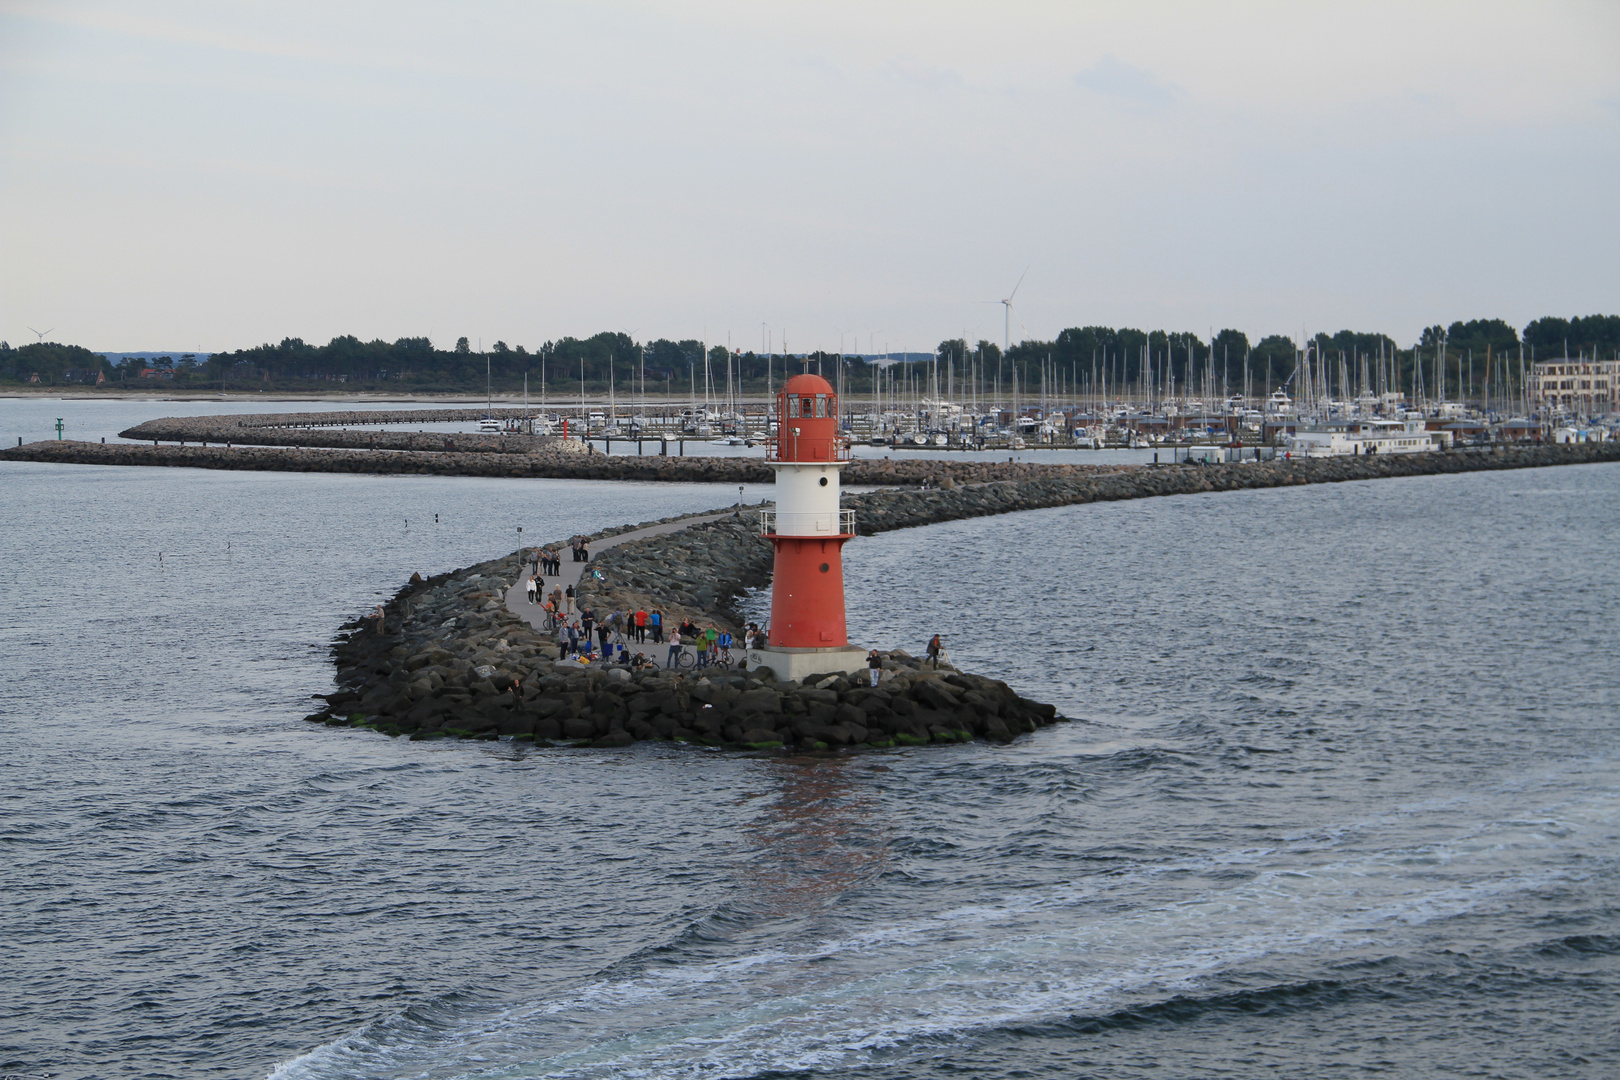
[308,526,1061,750]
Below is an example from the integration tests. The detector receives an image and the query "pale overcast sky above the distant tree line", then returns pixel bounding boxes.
[0,0,1620,351]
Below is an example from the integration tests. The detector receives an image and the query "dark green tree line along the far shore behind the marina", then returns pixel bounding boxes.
[0,316,1620,400]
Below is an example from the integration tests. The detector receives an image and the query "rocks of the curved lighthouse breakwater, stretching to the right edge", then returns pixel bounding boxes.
[309,444,1620,748]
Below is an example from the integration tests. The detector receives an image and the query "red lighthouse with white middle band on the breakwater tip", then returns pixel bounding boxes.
[748,372,867,680]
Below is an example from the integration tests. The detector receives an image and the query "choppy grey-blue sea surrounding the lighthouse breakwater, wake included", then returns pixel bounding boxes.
[0,408,1620,1080]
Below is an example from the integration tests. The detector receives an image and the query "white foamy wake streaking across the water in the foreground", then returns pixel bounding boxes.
[272,777,1620,1080]
